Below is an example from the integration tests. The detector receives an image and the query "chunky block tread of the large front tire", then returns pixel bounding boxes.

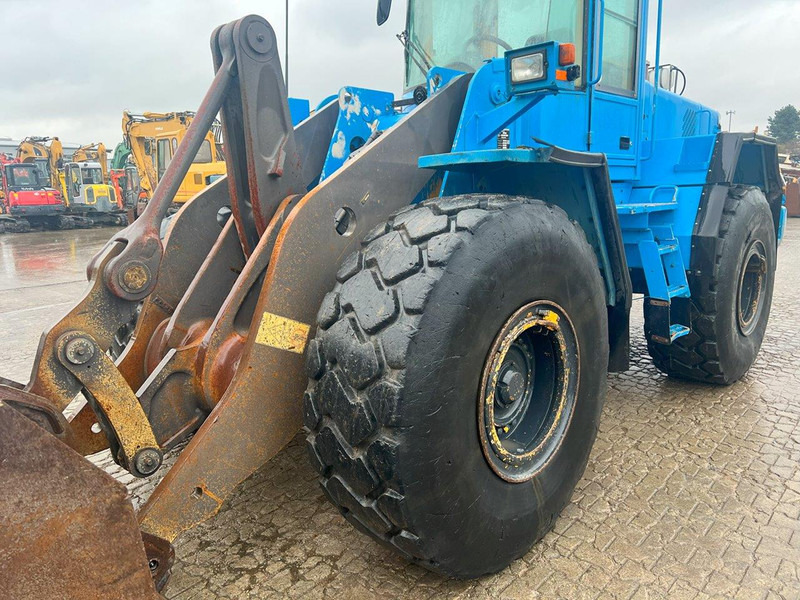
[303,195,588,569]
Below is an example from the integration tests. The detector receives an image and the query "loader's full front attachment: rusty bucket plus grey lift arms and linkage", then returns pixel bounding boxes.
[0,11,469,600]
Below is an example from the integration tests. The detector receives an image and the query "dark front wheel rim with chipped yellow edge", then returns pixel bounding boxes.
[478,301,580,483]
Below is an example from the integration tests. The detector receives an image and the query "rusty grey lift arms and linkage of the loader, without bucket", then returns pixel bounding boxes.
[0,16,468,597]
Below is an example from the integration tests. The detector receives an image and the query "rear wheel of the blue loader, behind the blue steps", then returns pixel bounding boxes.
[647,186,777,385]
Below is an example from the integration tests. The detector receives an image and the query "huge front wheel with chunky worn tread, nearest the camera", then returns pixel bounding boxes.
[304,196,608,578]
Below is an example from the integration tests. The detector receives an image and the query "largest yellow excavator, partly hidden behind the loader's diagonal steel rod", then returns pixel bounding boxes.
[122,111,225,208]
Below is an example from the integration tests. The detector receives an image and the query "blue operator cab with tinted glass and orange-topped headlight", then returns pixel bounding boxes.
[378,0,700,181]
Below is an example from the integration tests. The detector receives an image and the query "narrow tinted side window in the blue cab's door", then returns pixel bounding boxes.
[600,0,640,95]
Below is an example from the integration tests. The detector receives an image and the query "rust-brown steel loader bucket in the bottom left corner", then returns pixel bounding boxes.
[0,401,169,600]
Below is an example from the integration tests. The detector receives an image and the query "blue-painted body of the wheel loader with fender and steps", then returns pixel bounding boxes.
[304,0,786,356]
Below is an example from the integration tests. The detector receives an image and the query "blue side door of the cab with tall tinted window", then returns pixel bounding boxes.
[589,0,642,181]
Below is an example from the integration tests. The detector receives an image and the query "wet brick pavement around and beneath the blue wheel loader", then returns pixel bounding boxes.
[0,220,800,600]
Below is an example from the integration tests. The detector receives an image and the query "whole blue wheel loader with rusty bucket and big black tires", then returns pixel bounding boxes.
[0,0,785,600]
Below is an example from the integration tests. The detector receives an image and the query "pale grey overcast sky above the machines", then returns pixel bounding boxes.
[0,0,800,149]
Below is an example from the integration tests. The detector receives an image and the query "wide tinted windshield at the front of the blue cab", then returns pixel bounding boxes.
[406,0,584,88]
